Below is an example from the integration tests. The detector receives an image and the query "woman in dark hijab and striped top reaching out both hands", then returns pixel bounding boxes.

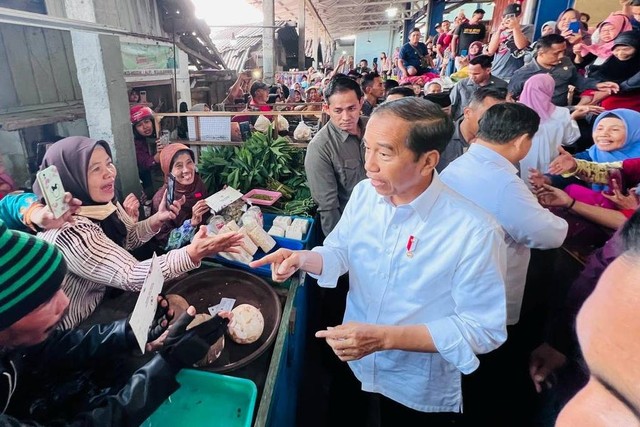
[34,136,242,329]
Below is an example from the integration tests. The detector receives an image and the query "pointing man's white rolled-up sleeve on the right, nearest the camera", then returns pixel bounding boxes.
[426,230,507,374]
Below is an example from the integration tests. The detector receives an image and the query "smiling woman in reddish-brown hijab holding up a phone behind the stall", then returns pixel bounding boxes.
[152,143,209,250]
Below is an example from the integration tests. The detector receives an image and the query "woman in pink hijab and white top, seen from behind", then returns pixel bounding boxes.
[520,74,581,187]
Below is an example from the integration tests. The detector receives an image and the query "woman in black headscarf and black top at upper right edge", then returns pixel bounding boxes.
[579,31,640,111]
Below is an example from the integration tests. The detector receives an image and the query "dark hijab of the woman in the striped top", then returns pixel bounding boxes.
[33,136,127,247]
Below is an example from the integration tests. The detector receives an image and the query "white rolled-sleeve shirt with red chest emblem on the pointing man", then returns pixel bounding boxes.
[313,172,506,412]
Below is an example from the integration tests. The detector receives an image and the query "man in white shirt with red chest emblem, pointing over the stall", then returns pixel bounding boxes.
[252,97,506,426]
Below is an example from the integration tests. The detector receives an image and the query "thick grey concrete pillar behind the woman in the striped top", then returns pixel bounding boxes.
[64,0,142,196]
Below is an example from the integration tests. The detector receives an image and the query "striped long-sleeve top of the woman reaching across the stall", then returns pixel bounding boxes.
[38,203,198,329]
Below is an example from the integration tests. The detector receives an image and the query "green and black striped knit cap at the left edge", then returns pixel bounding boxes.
[0,220,67,330]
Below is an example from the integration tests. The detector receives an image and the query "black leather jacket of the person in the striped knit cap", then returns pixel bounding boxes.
[0,320,179,426]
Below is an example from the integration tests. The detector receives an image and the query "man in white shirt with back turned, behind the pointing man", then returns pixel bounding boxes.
[442,103,567,425]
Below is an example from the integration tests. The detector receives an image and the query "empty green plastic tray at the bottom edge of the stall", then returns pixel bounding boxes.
[142,369,258,427]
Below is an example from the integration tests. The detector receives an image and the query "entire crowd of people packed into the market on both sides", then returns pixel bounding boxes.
[0,0,640,426]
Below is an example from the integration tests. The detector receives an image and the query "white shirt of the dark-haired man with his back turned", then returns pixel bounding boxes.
[442,144,568,325]
